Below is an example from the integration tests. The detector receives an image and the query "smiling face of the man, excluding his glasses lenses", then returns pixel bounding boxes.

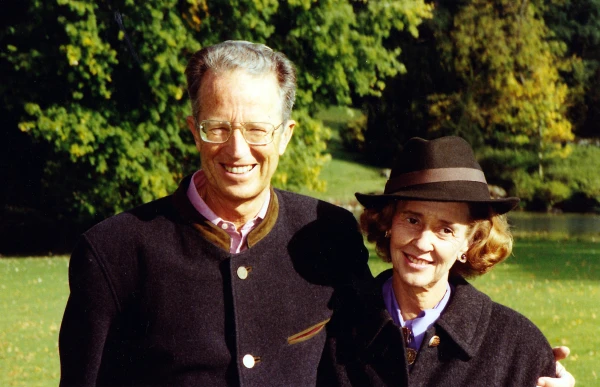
[187,70,295,208]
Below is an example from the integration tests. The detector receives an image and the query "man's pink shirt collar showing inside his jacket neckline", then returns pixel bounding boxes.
[187,170,271,254]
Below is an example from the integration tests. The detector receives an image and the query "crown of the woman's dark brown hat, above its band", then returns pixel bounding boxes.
[390,136,481,179]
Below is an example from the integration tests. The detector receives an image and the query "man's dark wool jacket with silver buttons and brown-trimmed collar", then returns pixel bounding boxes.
[59,177,370,386]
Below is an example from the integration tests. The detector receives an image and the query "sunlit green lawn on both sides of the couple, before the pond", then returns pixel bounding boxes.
[0,240,600,386]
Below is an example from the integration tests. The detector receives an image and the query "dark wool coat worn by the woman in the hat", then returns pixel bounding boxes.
[319,270,555,387]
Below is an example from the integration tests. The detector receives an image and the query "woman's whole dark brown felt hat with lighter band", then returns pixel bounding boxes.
[355,136,519,214]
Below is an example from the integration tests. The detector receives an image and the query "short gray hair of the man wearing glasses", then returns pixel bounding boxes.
[185,40,296,120]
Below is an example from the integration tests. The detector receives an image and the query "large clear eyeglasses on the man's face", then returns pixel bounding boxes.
[198,120,283,145]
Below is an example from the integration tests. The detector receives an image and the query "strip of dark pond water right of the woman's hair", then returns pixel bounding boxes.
[508,212,600,236]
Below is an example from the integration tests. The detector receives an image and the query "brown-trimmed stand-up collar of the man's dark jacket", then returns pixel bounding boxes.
[173,175,279,251]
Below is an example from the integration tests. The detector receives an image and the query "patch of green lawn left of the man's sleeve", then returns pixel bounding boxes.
[0,257,69,386]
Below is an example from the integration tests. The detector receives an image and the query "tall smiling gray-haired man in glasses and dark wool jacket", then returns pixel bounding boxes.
[60,41,569,386]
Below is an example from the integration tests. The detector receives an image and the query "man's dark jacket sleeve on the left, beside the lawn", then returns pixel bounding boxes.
[59,239,117,386]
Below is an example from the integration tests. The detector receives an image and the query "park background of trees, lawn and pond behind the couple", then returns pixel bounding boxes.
[0,0,600,386]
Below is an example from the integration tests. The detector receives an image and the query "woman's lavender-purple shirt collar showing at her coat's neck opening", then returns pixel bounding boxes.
[382,277,452,351]
